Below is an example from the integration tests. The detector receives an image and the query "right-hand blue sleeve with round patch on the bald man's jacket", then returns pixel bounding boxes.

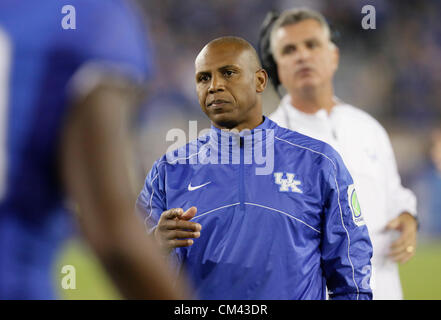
[322,153,372,300]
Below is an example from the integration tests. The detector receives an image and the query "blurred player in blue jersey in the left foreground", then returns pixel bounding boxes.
[0,0,189,299]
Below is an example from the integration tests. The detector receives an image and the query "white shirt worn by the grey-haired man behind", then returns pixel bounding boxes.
[270,95,416,299]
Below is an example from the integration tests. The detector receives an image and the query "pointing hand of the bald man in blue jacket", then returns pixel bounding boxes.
[154,207,202,252]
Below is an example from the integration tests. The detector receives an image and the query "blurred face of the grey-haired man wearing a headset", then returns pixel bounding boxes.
[273,19,338,93]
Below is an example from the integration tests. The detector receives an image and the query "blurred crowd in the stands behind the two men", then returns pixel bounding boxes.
[139,0,441,237]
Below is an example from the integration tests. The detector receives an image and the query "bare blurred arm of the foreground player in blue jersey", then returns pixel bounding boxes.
[60,83,192,299]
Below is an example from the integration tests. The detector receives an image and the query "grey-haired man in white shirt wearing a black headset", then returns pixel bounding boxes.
[260,9,417,299]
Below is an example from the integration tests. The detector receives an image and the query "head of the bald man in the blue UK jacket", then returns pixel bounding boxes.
[195,44,265,128]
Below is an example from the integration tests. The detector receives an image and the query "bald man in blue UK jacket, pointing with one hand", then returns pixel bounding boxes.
[137,37,372,299]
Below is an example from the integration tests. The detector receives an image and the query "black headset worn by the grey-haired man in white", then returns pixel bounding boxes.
[258,10,340,96]
